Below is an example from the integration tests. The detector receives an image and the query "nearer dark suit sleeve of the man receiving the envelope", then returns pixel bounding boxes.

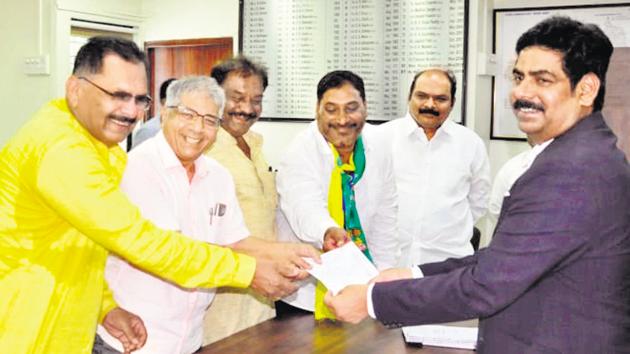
[372,161,605,325]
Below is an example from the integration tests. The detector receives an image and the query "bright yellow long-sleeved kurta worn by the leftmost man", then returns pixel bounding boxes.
[0,100,255,354]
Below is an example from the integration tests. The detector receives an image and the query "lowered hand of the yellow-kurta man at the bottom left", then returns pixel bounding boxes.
[103,307,147,354]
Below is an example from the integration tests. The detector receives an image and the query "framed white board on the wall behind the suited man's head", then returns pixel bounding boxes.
[490,3,630,141]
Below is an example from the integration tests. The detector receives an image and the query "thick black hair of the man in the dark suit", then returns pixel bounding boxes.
[516,16,613,112]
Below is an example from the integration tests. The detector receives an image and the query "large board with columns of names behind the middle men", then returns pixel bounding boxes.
[239,0,468,122]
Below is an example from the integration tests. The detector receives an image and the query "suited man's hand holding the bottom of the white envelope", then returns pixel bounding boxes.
[324,285,368,323]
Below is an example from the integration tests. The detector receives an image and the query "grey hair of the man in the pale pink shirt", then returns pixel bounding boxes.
[165,76,225,117]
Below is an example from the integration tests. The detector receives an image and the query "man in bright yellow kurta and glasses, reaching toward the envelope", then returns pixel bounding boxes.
[0,37,314,354]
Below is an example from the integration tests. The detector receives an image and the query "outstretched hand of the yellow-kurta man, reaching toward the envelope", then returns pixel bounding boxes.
[250,257,297,300]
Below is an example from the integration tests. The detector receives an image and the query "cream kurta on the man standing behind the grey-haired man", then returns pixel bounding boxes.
[204,129,277,344]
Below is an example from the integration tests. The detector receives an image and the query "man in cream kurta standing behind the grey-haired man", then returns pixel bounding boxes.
[204,56,276,344]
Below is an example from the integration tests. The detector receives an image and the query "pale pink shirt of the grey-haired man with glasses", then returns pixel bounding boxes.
[98,131,249,354]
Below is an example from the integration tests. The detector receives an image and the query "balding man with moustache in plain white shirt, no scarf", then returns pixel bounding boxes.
[379,69,490,266]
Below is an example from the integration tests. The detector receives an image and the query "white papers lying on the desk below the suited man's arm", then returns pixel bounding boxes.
[403,320,478,349]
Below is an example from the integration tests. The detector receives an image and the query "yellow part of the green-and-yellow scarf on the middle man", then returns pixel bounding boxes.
[314,143,356,320]
